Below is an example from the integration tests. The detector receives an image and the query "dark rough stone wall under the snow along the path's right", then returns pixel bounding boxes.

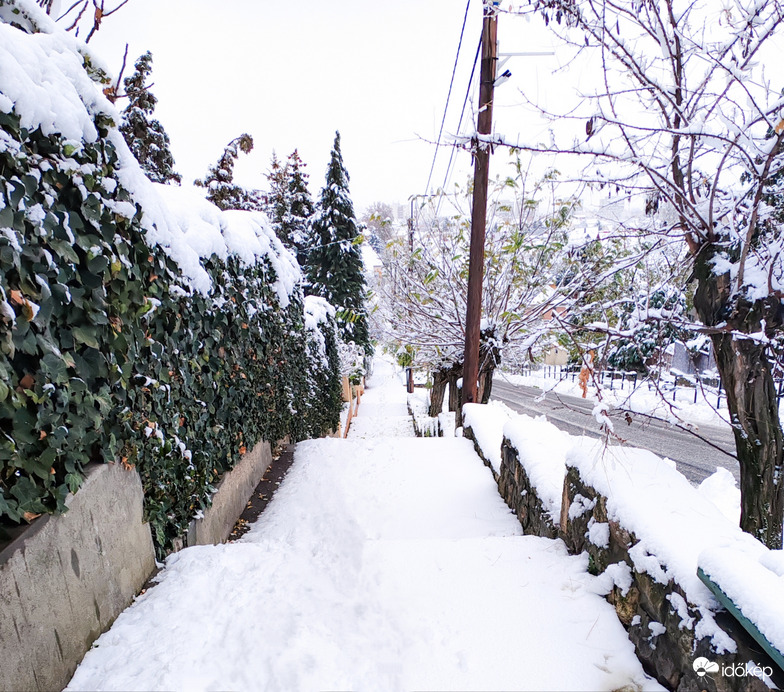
[494,440,784,692]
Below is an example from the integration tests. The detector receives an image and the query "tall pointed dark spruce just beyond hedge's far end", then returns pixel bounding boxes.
[307,132,372,354]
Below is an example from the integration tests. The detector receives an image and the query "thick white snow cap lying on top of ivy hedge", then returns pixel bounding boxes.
[0,0,300,296]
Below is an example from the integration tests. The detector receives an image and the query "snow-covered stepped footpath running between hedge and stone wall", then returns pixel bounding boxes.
[68,361,661,691]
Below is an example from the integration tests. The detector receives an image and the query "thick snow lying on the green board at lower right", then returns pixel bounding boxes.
[699,541,784,655]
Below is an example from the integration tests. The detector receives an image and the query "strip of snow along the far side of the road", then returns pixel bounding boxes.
[495,369,729,427]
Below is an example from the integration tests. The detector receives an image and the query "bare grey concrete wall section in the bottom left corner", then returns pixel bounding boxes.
[0,464,155,692]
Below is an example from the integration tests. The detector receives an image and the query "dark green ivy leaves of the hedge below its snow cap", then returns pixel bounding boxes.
[0,104,340,554]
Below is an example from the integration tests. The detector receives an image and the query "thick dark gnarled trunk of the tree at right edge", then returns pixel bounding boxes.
[694,260,784,549]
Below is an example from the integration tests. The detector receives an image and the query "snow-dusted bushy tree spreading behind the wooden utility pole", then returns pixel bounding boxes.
[379,161,612,415]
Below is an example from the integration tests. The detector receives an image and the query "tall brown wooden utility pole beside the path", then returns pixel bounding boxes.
[462,0,500,404]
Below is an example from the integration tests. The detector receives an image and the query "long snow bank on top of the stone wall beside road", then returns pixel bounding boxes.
[494,400,784,651]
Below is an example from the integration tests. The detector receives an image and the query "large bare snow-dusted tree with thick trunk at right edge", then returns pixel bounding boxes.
[508,0,784,548]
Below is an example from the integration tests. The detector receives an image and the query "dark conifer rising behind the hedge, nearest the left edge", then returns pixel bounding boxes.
[120,51,182,184]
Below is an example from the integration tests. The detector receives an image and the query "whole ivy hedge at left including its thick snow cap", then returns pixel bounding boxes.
[0,0,340,550]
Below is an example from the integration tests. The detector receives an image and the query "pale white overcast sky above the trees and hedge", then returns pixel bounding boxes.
[90,0,557,214]
